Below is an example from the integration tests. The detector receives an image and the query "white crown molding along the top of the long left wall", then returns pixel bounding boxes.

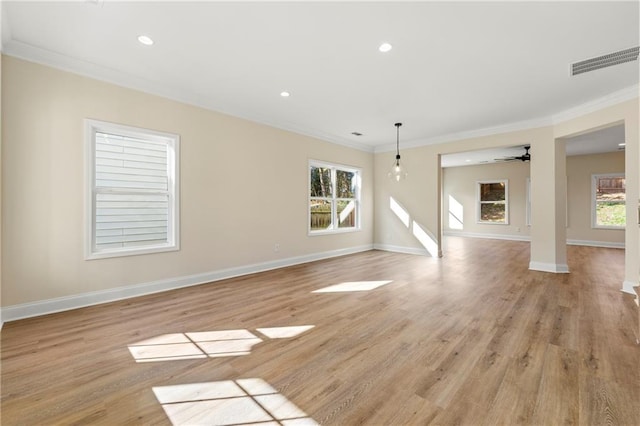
[3,40,373,153]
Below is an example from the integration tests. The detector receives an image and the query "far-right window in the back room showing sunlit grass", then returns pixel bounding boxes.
[592,173,627,228]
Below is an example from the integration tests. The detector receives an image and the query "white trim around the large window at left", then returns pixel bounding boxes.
[84,119,180,260]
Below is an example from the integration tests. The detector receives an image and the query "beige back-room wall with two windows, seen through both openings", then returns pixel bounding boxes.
[443,151,624,244]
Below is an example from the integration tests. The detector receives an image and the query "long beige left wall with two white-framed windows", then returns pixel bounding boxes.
[2,57,373,306]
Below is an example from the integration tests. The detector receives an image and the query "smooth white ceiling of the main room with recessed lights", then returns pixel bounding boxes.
[2,0,640,151]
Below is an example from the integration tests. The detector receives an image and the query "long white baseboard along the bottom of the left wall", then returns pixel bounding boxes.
[0,244,373,323]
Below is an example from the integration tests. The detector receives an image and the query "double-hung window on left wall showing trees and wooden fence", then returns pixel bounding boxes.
[308,161,360,234]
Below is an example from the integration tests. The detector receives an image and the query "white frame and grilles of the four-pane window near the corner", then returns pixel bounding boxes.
[307,160,362,236]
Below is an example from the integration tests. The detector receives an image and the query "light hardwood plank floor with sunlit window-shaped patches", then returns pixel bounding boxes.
[1,237,640,426]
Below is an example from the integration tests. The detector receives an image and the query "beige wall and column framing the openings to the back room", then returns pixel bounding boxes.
[374,98,640,282]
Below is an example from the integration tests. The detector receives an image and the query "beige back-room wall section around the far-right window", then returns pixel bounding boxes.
[567,151,624,244]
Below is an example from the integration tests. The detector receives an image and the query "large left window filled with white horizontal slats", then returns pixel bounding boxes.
[86,120,179,259]
